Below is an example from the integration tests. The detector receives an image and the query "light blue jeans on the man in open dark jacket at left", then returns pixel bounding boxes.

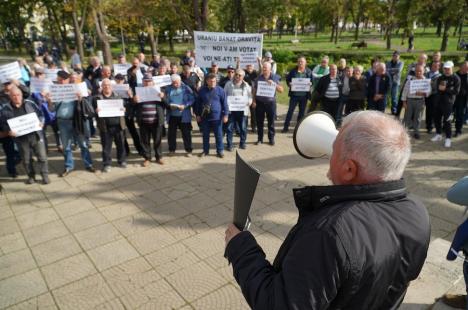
[57,119,93,170]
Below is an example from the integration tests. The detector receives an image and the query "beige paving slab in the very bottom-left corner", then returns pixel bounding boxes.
[0,269,47,308]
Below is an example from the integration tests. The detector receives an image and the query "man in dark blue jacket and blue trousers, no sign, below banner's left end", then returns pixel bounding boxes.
[195,73,229,158]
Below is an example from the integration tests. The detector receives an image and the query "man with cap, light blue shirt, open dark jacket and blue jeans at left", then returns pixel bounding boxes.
[47,70,95,177]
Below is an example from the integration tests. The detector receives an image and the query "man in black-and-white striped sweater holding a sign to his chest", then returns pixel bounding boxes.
[133,73,165,167]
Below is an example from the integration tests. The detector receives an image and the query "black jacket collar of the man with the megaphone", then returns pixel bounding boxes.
[293,179,407,211]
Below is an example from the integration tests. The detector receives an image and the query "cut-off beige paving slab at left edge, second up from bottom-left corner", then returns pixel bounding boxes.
[0,249,37,280]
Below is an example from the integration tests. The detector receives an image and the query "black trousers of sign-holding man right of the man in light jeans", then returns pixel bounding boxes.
[101,125,127,167]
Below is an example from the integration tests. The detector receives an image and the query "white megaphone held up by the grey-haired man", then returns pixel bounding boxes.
[293,111,338,159]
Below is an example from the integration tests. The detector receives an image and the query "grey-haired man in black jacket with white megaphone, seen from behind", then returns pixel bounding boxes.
[225,111,430,310]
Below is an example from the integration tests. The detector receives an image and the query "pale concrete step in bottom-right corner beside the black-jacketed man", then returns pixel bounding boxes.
[400,238,464,310]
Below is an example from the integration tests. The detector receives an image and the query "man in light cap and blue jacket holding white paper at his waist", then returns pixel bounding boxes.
[165,74,195,157]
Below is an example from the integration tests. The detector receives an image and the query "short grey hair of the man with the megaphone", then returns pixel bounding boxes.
[340,111,411,181]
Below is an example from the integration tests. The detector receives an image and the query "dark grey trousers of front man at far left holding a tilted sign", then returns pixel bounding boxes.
[16,133,49,178]
